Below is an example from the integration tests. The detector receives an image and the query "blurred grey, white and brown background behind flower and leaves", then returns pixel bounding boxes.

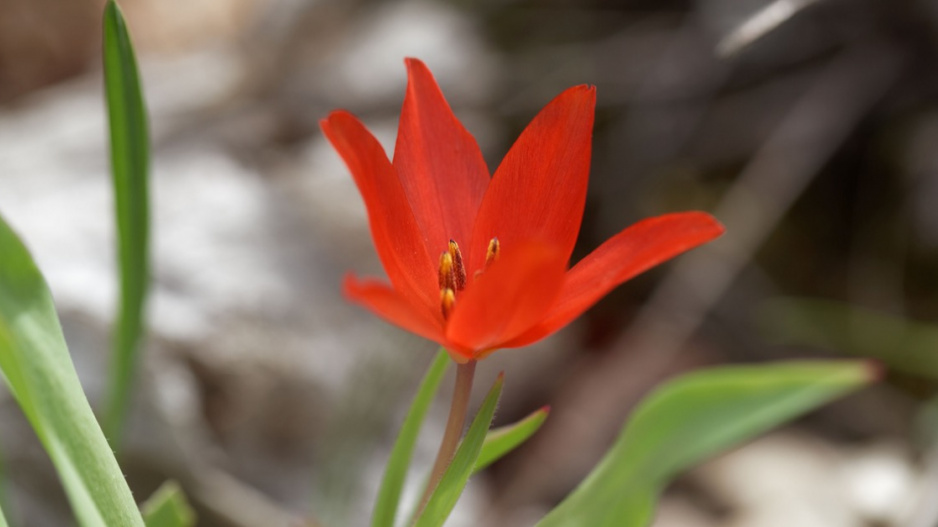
[0,0,938,527]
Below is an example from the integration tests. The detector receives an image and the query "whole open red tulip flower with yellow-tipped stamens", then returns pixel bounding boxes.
[320,59,723,363]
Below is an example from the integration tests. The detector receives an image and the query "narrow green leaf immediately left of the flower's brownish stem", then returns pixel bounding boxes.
[371,349,450,527]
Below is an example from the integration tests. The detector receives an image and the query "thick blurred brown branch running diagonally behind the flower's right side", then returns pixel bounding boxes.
[500,44,903,506]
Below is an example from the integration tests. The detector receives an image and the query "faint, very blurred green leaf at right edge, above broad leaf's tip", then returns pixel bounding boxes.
[759,299,938,379]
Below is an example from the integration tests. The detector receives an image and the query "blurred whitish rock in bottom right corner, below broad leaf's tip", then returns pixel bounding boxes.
[690,432,920,527]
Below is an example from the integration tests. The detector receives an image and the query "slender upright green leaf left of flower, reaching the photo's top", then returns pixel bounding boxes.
[104,0,150,449]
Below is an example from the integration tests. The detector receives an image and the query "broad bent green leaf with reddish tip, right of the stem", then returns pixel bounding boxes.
[538,361,874,527]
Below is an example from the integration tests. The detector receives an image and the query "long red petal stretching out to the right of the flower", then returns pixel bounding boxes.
[505,212,723,347]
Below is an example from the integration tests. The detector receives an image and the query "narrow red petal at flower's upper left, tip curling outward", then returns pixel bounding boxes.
[319,111,437,305]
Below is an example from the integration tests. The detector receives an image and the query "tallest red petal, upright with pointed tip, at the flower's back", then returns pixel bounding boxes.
[394,59,489,254]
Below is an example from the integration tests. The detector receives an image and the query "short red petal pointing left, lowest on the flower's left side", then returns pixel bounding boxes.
[342,274,444,344]
